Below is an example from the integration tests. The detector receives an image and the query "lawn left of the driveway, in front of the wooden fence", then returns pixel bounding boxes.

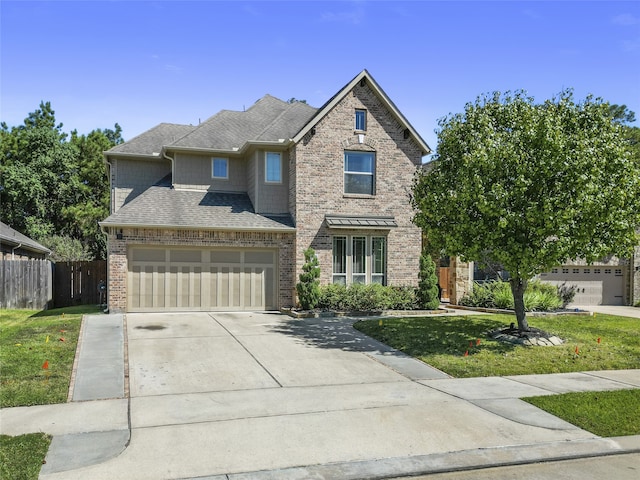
[0,306,100,408]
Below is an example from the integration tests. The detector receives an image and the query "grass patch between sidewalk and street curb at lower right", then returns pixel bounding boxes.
[523,390,640,437]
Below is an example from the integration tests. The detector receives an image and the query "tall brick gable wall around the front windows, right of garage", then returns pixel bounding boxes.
[289,84,422,285]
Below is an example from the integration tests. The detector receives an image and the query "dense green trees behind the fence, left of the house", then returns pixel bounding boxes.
[0,102,123,258]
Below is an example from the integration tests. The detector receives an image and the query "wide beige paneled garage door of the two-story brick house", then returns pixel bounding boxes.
[127,247,277,312]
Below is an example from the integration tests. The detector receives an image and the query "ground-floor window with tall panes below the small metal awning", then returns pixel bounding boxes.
[332,235,387,285]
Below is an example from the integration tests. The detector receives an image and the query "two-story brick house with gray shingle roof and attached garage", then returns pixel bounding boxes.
[101,70,430,311]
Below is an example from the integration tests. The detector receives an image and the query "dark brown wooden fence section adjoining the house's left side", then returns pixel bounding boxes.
[54,260,107,308]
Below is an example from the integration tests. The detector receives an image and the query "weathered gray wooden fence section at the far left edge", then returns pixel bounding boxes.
[0,259,53,310]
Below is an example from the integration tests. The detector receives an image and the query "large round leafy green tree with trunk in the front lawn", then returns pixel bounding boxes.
[413,90,640,331]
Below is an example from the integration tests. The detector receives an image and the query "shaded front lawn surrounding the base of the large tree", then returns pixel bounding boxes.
[355,314,640,377]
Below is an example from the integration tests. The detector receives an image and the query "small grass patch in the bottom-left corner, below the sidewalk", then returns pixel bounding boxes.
[0,433,51,480]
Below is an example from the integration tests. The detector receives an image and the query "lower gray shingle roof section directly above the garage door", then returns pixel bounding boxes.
[100,183,295,231]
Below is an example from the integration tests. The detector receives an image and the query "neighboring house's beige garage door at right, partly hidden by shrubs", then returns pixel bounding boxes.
[540,265,624,305]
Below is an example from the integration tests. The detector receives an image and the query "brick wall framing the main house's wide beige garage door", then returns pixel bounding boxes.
[108,228,295,313]
